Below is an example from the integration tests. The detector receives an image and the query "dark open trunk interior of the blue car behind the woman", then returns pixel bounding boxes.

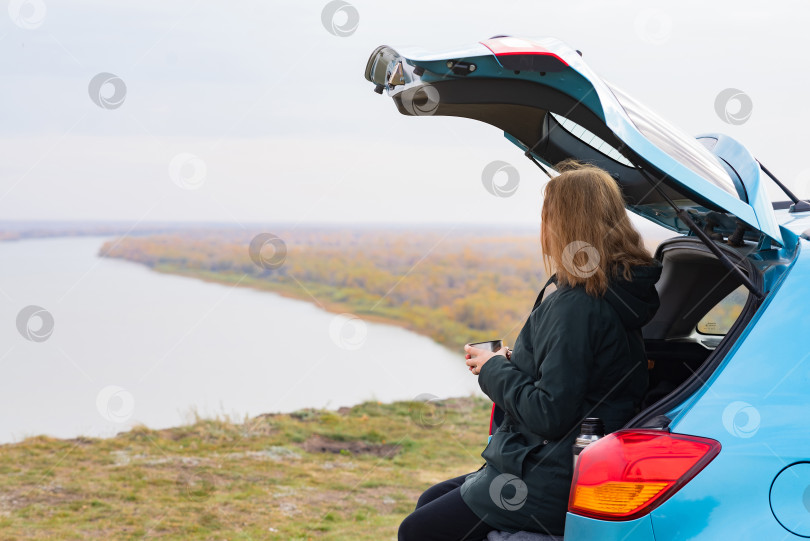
[627,237,762,428]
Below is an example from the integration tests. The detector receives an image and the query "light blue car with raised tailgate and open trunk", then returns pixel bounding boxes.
[365,36,810,541]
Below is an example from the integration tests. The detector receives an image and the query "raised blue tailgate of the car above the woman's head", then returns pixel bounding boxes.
[365,36,783,246]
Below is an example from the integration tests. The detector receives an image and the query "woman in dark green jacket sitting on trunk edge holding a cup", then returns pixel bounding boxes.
[399,161,661,541]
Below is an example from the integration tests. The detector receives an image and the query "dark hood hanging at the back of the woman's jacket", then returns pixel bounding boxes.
[605,260,663,329]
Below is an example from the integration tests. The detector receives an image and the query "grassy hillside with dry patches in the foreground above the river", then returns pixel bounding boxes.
[0,398,491,541]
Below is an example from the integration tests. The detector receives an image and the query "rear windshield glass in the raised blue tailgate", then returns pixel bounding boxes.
[603,79,739,197]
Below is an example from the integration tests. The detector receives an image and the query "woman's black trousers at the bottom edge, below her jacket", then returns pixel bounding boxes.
[398,473,494,541]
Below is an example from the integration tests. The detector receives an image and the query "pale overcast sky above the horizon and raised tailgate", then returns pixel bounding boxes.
[0,0,810,225]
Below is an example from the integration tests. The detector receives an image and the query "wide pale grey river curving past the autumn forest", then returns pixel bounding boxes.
[0,237,481,443]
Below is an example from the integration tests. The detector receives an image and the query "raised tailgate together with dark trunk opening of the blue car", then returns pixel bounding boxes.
[365,36,772,428]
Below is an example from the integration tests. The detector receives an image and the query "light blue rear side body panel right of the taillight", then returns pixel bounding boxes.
[652,240,810,541]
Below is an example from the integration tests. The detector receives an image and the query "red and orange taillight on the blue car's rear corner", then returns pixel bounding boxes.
[568,430,720,520]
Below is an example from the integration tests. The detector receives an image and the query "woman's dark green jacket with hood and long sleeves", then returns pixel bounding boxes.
[461,262,661,535]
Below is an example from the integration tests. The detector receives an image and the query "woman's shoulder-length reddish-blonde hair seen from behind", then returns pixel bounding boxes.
[540,160,653,296]
